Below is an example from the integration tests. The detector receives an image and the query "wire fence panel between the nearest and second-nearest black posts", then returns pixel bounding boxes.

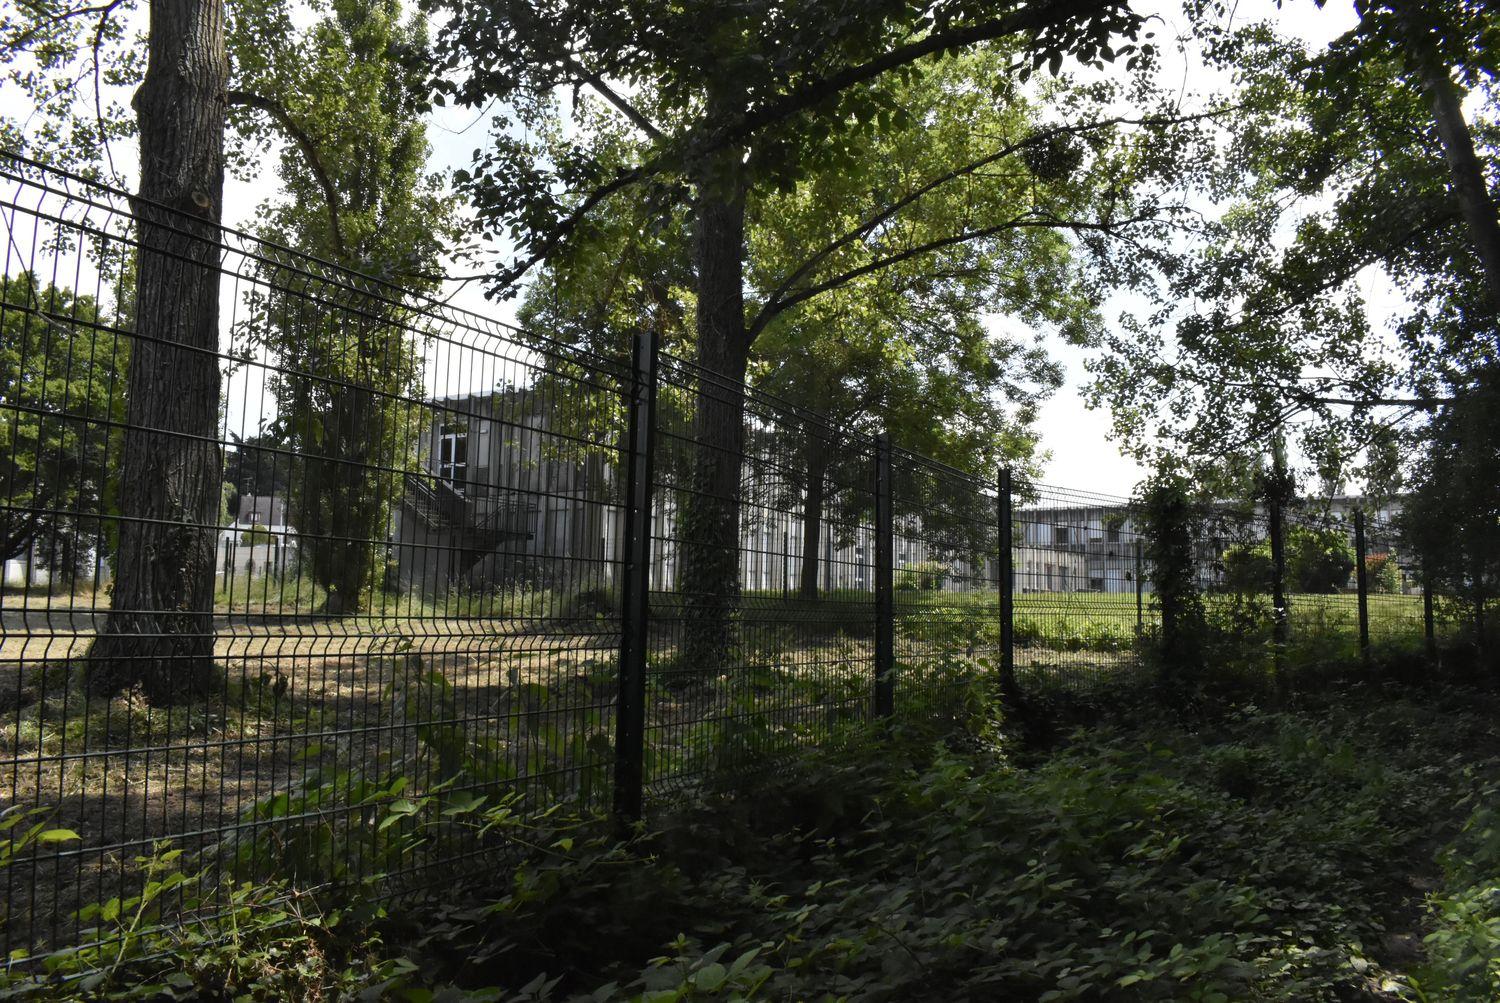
[645,357,875,795]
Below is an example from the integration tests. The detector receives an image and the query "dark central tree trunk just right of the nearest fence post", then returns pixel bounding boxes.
[680,150,750,675]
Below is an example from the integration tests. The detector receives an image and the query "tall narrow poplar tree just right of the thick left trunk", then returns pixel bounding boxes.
[237,0,455,615]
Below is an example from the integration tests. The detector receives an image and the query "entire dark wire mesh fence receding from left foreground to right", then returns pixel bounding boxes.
[0,159,1442,964]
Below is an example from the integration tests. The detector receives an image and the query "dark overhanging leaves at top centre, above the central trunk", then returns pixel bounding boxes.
[434,0,1149,289]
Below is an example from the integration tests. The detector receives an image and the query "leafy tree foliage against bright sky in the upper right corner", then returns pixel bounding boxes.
[1094,0,1500,490]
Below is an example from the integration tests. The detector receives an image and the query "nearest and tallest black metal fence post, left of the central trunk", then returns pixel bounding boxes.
[615,333,657,822]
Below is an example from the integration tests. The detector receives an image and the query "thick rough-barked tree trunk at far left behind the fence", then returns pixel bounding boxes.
[89,0,230,703]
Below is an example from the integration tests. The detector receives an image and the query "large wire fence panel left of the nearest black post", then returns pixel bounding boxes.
[0,156,624,963]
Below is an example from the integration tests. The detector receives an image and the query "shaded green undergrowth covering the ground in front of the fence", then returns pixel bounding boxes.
[9,671,1500,1002]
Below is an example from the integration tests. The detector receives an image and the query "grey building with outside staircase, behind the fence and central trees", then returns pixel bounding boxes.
[392,390,966,594]
